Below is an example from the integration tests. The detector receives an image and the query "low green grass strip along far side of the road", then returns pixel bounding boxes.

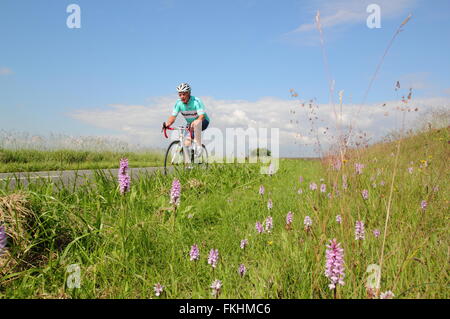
[0,148,164,173]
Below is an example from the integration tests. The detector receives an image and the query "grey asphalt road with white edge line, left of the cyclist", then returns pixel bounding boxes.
[0,167,169,189]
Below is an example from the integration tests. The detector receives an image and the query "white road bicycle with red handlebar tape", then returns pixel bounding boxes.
[161,122,208,175]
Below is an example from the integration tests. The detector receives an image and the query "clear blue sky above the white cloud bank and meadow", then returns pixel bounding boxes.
[0,0,450,155]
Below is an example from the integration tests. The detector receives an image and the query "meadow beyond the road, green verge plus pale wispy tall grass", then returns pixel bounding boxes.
[0,130,165,173]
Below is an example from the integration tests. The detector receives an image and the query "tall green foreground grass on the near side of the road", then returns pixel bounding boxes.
[0,129,449,298]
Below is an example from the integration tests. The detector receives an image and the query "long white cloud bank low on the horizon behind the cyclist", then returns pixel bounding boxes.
[69,92,450,156]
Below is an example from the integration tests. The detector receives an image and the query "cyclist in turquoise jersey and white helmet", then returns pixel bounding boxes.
[163,83,209,156]
